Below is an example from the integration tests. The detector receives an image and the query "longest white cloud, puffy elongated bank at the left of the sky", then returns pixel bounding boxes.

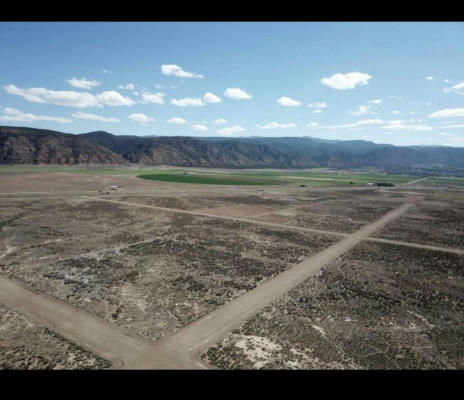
[3,84,135,108]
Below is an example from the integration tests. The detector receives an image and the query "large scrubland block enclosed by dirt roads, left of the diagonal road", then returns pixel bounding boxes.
[0,192,336,346]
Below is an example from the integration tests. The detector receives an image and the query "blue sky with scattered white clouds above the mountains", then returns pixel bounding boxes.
[0,22,464,146]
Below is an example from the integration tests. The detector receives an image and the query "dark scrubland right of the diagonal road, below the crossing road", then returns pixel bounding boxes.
[203,242,464,369]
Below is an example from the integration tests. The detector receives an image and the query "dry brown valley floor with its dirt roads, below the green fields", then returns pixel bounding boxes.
[0,167,464,369]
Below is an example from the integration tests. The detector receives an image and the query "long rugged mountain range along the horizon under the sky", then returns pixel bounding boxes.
[0,126,464,175]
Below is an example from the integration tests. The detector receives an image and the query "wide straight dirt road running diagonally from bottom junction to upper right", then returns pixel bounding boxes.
[126,202,414,369]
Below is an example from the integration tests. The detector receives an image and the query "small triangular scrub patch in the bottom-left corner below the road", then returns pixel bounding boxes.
[0,304,110,369]
